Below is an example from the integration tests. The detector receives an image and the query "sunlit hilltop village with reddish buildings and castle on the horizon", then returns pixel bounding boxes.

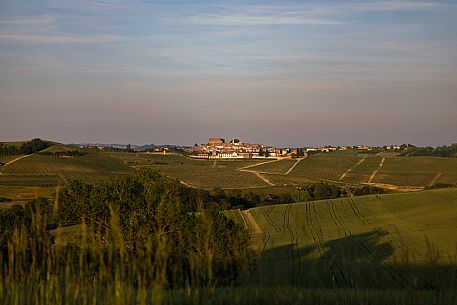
[183,138,401,159]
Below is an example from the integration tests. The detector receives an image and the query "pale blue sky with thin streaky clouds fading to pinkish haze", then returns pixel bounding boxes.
[0,0,457,147]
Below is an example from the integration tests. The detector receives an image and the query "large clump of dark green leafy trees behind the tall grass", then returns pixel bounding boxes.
[0,170,250,288]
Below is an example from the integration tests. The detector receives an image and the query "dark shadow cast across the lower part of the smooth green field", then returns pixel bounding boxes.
[249,231,457,290]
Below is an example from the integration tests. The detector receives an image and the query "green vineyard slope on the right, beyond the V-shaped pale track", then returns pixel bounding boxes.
[250,152,457,190]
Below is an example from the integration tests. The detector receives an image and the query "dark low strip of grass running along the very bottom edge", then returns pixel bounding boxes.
[0,278,457,305]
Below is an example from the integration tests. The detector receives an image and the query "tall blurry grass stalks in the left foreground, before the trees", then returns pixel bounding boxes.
[0,200,244,304]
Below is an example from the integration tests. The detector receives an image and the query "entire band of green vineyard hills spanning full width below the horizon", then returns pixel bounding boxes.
[0,145,457,195]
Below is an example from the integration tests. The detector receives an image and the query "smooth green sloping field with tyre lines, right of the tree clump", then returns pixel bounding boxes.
[227,189,457,289]
